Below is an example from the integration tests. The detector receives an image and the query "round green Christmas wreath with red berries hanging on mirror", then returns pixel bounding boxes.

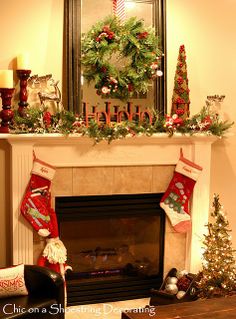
[82,17,162,100]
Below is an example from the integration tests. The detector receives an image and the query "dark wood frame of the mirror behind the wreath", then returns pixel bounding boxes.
[62,0,166,114]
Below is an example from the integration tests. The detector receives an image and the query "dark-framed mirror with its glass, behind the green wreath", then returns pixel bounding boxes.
[63,0,166,114]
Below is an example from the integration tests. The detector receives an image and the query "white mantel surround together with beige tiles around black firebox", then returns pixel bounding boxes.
[6,134,217,304]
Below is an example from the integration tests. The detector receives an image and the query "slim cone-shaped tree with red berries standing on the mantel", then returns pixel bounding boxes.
[171,45,190,118]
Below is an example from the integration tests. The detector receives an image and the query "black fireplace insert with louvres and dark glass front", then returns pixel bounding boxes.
[56,193,165,305]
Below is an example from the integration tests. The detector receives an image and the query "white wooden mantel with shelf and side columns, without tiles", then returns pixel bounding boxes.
[0,133,217,273]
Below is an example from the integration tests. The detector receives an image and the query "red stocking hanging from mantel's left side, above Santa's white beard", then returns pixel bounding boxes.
[21,158,55,237]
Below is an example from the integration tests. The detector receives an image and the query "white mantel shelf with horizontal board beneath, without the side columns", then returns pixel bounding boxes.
[0,133,217,167]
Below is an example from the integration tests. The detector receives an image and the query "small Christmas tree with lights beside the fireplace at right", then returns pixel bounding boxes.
[198,195,236,298]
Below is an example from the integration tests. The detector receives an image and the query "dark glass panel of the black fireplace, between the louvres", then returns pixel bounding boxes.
[60,214,161,277]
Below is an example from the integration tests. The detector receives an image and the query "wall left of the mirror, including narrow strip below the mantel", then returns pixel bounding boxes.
[0,0,63,267]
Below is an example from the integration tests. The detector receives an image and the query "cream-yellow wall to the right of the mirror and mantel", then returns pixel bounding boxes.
[167,0,236,248]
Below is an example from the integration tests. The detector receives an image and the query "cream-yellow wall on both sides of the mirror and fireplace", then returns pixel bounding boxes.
[0,0,236,266]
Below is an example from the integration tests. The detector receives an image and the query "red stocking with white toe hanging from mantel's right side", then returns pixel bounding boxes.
[160,149,202,233]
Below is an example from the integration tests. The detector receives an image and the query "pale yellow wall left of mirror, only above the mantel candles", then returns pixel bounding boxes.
[0,0,63,86]
